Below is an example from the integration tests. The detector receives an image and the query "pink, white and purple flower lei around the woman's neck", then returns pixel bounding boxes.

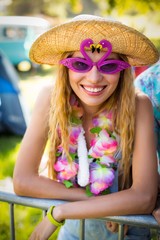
[54,95,118,196]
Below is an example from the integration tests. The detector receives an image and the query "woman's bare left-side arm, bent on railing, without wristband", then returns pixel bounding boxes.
[13,86,87,201]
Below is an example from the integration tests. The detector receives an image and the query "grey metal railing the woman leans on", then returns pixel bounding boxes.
[0,191,160,240]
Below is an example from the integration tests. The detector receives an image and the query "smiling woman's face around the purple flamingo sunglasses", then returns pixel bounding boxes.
[68,51,120,111]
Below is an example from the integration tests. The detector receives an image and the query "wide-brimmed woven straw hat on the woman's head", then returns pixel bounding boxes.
[30,15,159,66]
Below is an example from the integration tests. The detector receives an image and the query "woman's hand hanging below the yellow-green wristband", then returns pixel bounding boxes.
[29,217,57,240]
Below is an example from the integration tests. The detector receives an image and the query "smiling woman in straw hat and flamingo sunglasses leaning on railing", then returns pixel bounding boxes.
[14,15,158,240]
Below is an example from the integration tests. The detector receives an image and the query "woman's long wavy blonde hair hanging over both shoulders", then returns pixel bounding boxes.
[48,53,135,189]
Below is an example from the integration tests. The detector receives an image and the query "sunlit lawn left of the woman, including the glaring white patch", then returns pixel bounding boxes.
[0,66,56,240]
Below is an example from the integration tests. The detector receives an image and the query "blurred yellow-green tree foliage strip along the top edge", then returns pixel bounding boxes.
[1,0,160,17]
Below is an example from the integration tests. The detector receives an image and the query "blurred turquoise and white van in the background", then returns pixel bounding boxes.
[0,16,50,71]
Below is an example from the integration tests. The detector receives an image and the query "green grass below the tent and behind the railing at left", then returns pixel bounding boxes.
[0,135,57,240]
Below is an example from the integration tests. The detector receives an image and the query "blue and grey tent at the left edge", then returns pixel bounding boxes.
[0,48,29,136]
